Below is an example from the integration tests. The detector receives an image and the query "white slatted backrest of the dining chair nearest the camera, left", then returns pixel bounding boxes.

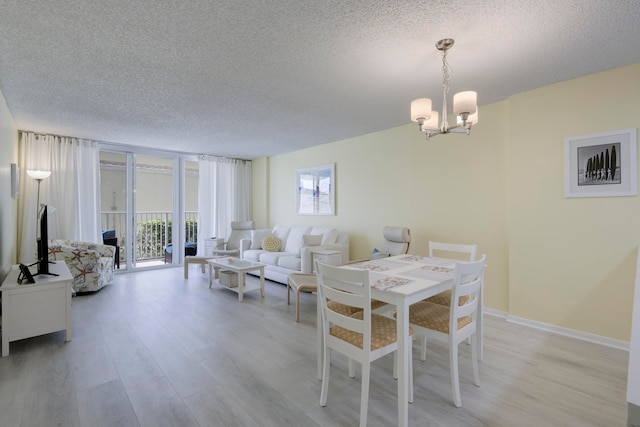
[316,262,371,354]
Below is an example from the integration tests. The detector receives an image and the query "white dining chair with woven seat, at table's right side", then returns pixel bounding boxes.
[409,255,487,408]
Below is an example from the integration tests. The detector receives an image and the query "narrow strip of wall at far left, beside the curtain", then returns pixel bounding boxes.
[0,87,18,280]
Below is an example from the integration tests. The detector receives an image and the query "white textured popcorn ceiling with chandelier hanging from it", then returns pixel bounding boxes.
[0,0,640,159]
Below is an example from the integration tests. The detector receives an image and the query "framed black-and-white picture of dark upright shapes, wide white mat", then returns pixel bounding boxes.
[564,129,638,197]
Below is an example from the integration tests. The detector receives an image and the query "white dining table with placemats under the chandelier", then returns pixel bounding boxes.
[317,254,482,427]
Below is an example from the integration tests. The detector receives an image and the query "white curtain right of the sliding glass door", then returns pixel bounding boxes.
[198,156,253,254]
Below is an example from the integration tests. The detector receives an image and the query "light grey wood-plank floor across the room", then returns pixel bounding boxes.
[0,266,628,427]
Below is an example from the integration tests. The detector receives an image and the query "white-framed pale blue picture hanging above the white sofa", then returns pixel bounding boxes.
[296,163,336,215]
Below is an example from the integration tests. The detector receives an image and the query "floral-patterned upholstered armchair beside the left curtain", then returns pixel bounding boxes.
[49,240,115,292]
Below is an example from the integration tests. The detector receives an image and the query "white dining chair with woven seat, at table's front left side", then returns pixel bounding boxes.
[316,262,413,427]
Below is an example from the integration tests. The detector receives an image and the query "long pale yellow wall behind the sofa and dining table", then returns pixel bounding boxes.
[253,64,640,341]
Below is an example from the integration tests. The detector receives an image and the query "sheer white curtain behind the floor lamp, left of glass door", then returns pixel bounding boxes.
[18,132,102,263]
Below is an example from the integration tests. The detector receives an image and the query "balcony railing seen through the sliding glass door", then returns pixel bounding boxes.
[101,211,198,263]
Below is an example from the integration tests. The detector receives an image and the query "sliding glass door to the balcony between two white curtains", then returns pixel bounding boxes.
[100,151,198,270]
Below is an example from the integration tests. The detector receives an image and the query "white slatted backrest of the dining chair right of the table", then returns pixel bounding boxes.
[449,254,487,333]
